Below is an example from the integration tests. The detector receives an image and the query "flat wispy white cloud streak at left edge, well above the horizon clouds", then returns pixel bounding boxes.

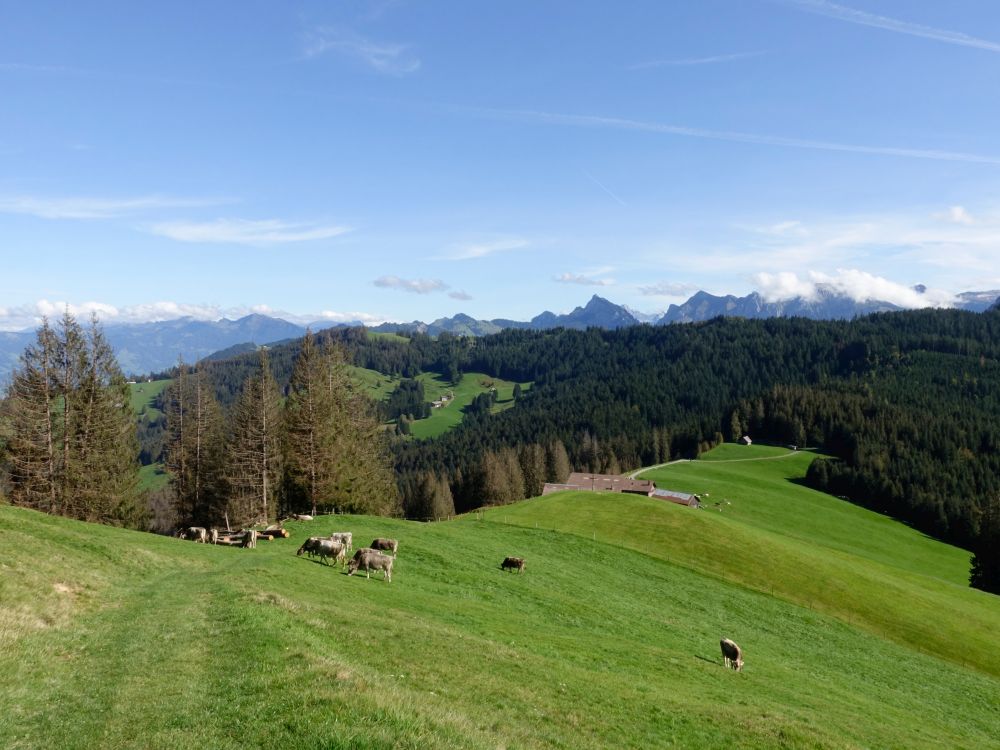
[0,195,230,219]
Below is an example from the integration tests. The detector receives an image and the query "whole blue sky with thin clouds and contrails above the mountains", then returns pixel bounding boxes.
[0,0,1000,328]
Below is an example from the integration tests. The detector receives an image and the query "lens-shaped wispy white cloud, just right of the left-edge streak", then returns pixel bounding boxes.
[149,219,351,245]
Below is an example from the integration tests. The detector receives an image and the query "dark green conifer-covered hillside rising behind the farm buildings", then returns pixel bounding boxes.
[184,310,1000,592]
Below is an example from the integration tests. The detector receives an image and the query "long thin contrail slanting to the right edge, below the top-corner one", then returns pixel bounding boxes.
[465,109,1000,166]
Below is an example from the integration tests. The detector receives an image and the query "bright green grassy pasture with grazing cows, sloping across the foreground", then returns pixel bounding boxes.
[0,449,1000,748]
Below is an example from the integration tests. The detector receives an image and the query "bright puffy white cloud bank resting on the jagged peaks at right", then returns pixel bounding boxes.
[754,268,955,308]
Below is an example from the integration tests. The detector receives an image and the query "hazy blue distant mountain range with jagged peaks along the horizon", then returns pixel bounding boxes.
[0,287,1000,379]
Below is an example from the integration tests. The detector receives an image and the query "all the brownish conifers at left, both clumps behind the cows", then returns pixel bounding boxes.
[0,324,401,531]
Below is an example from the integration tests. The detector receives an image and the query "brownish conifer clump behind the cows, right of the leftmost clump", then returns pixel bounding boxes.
[163,333,400,525]
